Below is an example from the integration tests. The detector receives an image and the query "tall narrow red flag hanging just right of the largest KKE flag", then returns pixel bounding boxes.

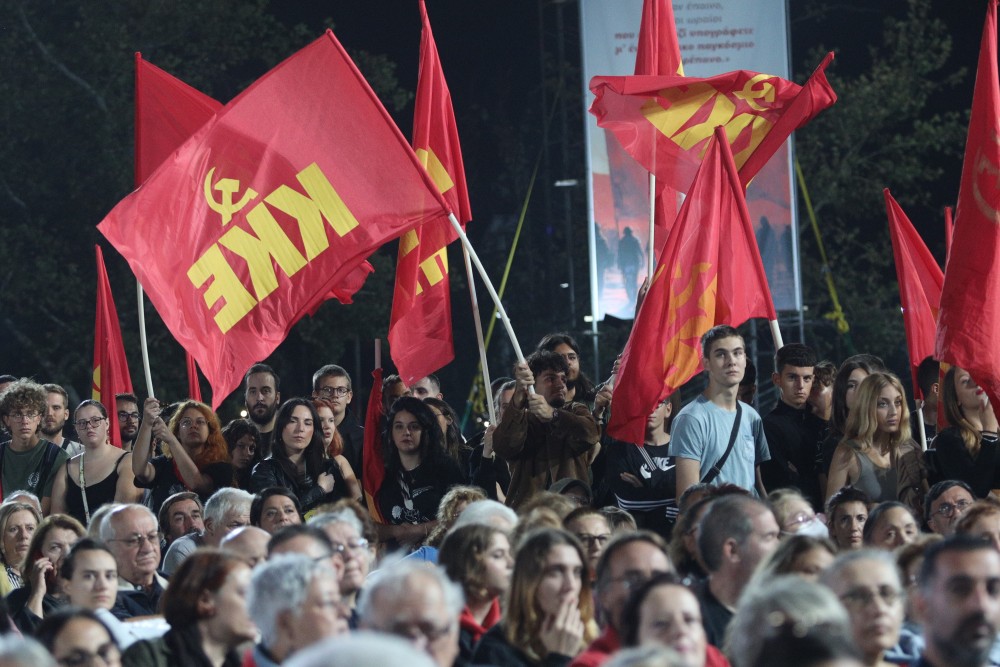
[389,0,472,385]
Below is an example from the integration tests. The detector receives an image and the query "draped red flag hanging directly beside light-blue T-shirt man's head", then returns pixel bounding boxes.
[608,128,777,445]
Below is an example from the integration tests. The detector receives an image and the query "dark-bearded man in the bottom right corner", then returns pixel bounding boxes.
[915,535,1000,667]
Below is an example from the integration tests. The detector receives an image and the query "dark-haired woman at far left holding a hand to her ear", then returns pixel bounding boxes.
[7,514,87,634]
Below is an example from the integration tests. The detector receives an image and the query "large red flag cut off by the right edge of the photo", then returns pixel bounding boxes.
[936,0,1000,412]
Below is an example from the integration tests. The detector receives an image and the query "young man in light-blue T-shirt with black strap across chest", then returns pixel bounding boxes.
[670,324,771,498]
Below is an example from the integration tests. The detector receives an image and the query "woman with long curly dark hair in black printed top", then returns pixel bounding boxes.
[375,396,465,545]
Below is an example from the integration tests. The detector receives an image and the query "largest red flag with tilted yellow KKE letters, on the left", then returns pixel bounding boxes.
[99,32,449,406]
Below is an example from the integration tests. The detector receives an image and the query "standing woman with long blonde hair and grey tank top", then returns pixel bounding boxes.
[826,373,927,512]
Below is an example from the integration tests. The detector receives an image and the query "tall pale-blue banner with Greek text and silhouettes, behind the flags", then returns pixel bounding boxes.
[580,0,801,320]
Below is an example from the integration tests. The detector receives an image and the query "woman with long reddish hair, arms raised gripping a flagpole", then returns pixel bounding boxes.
[132,397,233,514]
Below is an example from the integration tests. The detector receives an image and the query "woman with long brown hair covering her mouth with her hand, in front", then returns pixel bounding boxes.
[472,528,597,667]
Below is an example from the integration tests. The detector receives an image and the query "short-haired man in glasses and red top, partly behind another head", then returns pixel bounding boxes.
[570,530,674,667]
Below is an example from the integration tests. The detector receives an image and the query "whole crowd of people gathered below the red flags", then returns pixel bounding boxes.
[0,325,1000,667]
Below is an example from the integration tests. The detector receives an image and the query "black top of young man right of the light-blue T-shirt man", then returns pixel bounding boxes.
[760,400,825,511]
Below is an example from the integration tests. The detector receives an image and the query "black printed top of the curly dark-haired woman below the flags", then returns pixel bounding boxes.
[376,455,465,526]
